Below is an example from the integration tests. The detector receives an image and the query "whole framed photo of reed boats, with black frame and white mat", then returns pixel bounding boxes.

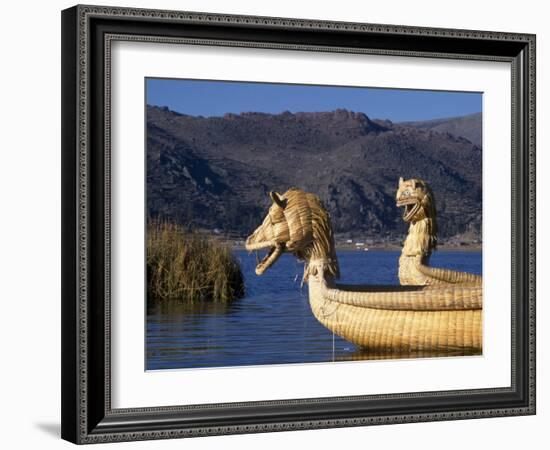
[62,6,535,443]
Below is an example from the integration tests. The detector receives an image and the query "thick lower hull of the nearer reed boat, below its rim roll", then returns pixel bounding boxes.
[309,281,482,353]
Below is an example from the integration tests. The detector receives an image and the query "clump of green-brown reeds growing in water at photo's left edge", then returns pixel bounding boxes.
[147,221,248,304]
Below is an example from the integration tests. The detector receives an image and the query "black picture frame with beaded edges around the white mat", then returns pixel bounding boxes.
[62,5,535,444]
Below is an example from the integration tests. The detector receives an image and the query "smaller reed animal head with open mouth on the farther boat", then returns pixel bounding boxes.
[395,178,437,252]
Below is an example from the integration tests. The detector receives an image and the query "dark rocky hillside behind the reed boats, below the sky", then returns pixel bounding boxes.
[147,106,481,240]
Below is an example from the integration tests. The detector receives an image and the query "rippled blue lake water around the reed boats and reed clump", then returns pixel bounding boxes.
[146,250,481,370]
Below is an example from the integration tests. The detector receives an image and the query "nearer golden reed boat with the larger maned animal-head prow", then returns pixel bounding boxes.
[246,188,482,354]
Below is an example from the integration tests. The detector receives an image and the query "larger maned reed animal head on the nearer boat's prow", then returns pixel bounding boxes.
[245,188,339,277]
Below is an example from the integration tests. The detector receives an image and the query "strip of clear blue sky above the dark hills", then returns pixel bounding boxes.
[146,78,482,122]
